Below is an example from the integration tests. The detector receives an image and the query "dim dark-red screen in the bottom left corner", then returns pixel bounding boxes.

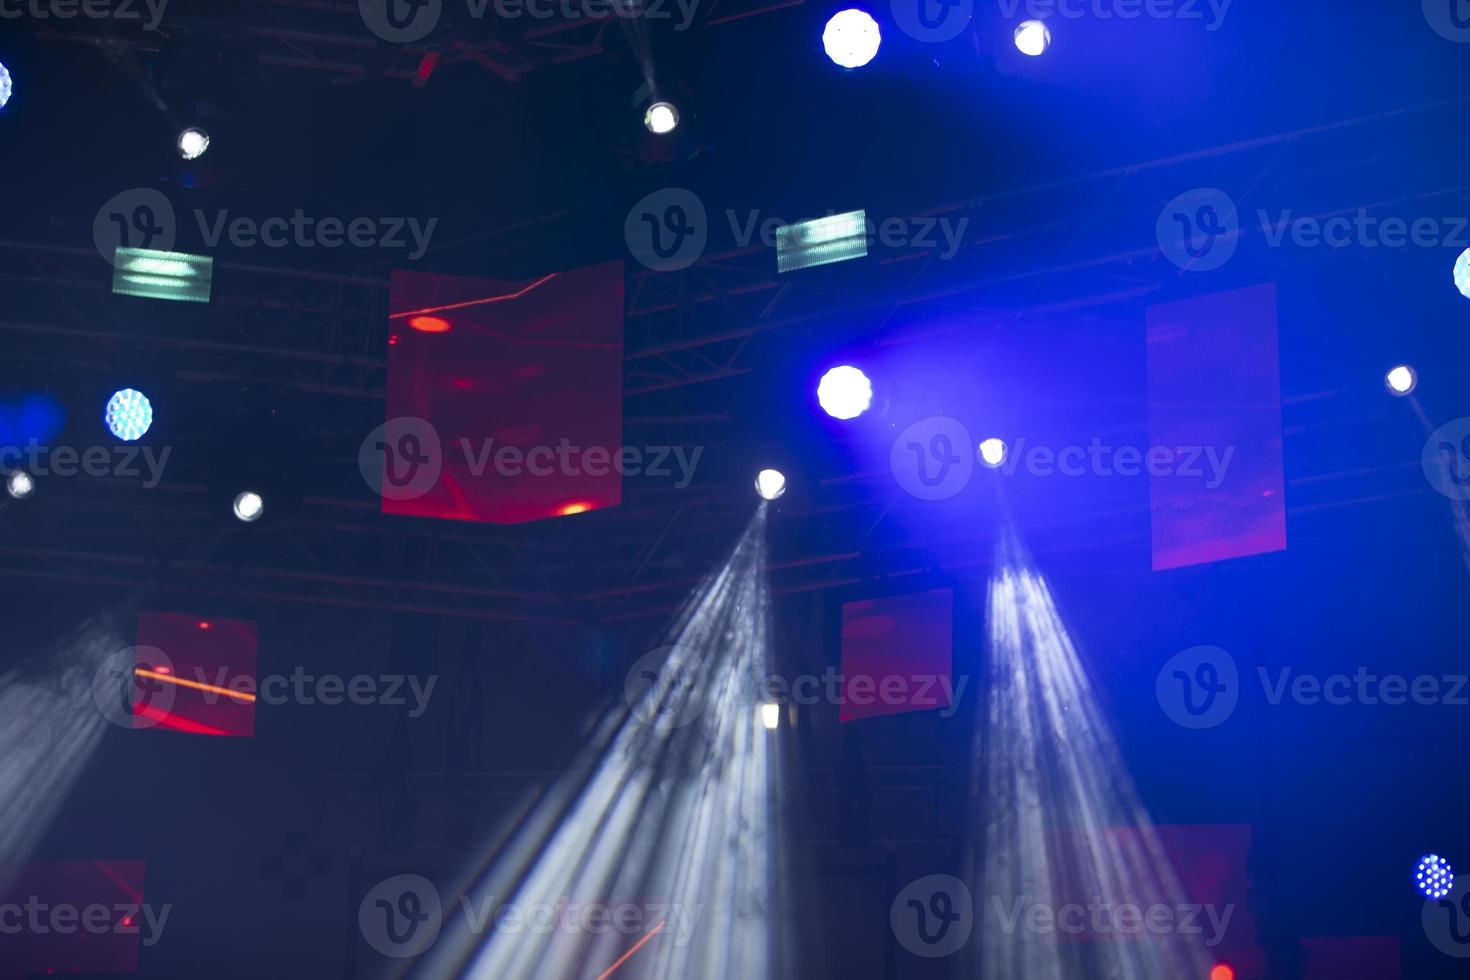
[0,861,147,980]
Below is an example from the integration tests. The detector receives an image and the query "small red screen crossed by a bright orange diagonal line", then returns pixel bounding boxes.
[132,613,257,738]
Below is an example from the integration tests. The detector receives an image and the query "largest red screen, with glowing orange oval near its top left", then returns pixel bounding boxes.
[382,262,629,525]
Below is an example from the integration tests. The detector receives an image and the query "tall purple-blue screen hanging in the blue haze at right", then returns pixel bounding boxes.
[1148,284,1286,572]
